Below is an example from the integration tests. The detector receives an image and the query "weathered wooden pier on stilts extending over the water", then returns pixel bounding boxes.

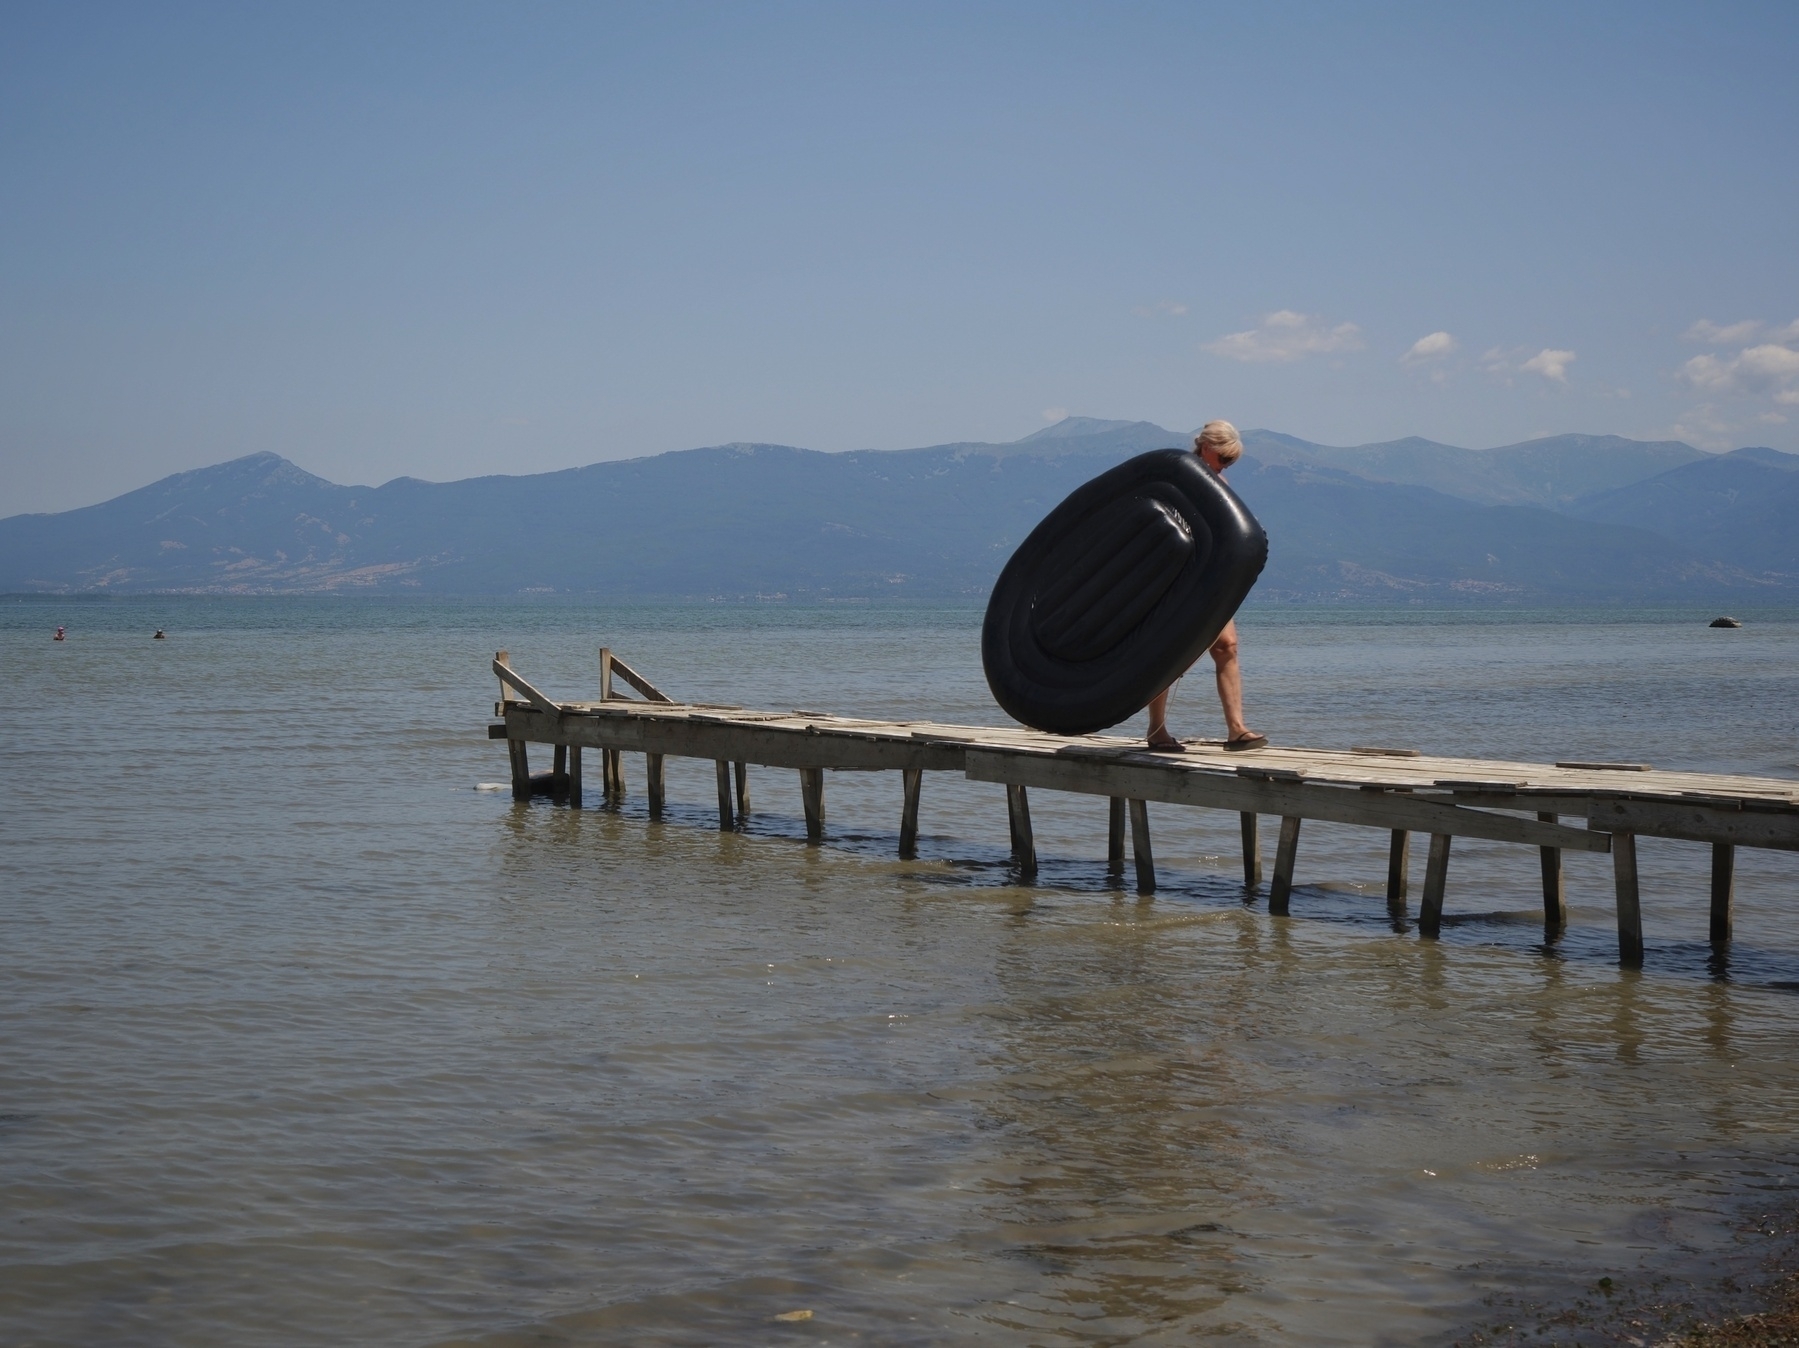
[488,650,1799,965]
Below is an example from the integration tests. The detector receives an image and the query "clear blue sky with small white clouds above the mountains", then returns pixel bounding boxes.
[0,0,1799,515]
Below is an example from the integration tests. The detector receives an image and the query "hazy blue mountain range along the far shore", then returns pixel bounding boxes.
[0,418,1799,601]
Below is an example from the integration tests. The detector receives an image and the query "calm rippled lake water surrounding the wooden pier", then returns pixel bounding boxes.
[0,599,1799,1346]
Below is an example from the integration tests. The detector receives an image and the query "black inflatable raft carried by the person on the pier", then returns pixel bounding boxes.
[980,450,1268,734]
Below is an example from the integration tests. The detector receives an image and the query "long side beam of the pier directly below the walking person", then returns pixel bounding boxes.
[971,745,1612,851]
